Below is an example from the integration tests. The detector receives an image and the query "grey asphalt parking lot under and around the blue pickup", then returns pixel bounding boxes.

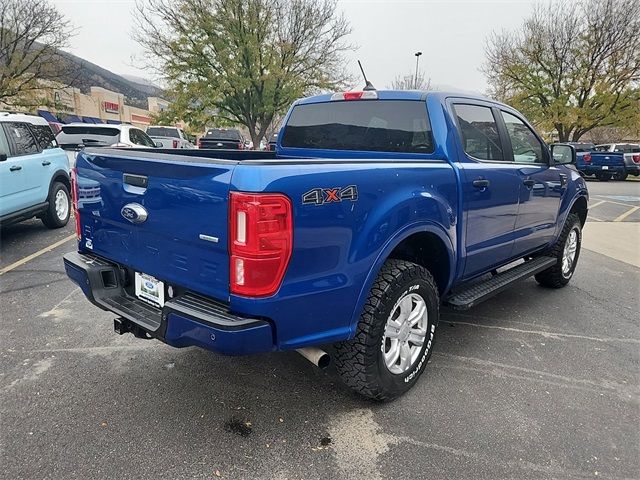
[0,181,640,480]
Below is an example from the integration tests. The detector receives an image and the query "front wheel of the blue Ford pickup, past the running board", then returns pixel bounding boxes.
[535,213,582,288]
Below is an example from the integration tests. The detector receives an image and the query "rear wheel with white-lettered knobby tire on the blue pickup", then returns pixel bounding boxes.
[335,259,440,401]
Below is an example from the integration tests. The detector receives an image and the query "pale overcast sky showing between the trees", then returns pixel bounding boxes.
[52,0,538,92]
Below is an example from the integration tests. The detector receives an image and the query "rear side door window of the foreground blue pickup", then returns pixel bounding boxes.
[454,104,504,161]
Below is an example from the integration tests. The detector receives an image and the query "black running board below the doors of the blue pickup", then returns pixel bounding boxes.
[444,257,558,310]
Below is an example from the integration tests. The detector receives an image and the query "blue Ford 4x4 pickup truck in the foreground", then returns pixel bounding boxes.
[64,90,588,400]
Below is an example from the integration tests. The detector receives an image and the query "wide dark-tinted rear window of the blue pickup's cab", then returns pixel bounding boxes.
[282,100,433,153]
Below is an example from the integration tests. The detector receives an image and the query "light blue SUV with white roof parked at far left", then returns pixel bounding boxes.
[0,112,71,228]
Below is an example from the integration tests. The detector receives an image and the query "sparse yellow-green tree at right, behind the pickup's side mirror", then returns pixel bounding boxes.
[483,0,640,141]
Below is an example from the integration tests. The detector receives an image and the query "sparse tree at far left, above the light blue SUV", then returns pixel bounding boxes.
[0,0,72,106]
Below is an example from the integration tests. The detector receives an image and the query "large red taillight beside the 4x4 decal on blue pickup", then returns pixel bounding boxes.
[229,192,293,297]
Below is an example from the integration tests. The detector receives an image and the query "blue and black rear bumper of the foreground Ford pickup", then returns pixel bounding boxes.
[64,252,274,355]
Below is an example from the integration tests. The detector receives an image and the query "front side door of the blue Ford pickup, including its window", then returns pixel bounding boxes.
[500,110,568,256]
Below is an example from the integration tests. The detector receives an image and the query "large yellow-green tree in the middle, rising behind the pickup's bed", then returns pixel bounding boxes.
[135,0,351,145]
